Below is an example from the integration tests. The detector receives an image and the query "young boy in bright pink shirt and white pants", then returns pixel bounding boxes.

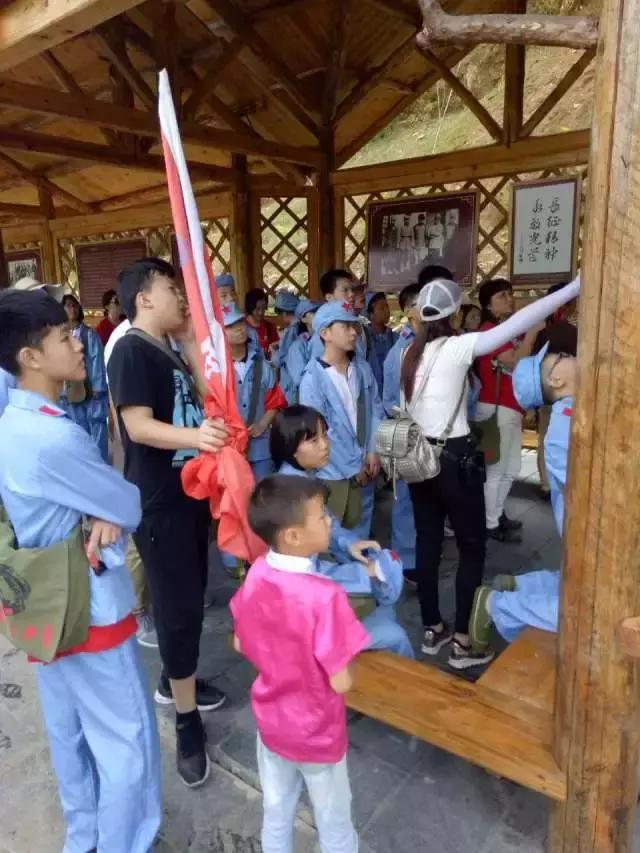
[230,475,370,853]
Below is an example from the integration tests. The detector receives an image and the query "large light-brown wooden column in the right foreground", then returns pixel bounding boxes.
[550,0,640,853]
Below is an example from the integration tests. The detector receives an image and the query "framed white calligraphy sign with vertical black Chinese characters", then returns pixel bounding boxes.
[509,177,580,287]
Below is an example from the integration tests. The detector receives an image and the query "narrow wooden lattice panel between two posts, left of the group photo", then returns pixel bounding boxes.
[260,197,309,296]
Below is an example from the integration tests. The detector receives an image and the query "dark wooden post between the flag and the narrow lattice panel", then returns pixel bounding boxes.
[230,154,260,307]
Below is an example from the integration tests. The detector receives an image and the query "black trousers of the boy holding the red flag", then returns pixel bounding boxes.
[133,500,211,679]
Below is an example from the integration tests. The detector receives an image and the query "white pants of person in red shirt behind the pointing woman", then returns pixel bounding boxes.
[476,403,522,530]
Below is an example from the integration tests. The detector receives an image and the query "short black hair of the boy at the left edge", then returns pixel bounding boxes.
[0,290,68,376]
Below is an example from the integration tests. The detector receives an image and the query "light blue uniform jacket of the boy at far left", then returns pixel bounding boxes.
[0,389,141,625]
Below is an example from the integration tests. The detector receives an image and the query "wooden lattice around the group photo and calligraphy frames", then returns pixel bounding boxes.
[343,166,586,292]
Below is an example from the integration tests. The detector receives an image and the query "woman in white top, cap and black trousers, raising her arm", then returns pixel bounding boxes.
[401,278,580,669]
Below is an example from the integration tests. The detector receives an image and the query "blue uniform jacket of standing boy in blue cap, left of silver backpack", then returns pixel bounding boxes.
[300,357,384,480]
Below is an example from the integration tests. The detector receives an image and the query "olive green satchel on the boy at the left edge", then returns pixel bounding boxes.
[0,505,90,663]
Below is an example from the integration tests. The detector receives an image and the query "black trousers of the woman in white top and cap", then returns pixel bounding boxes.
[409,437,486,634]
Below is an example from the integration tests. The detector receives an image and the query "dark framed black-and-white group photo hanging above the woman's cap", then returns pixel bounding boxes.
[366,189,480,291]
